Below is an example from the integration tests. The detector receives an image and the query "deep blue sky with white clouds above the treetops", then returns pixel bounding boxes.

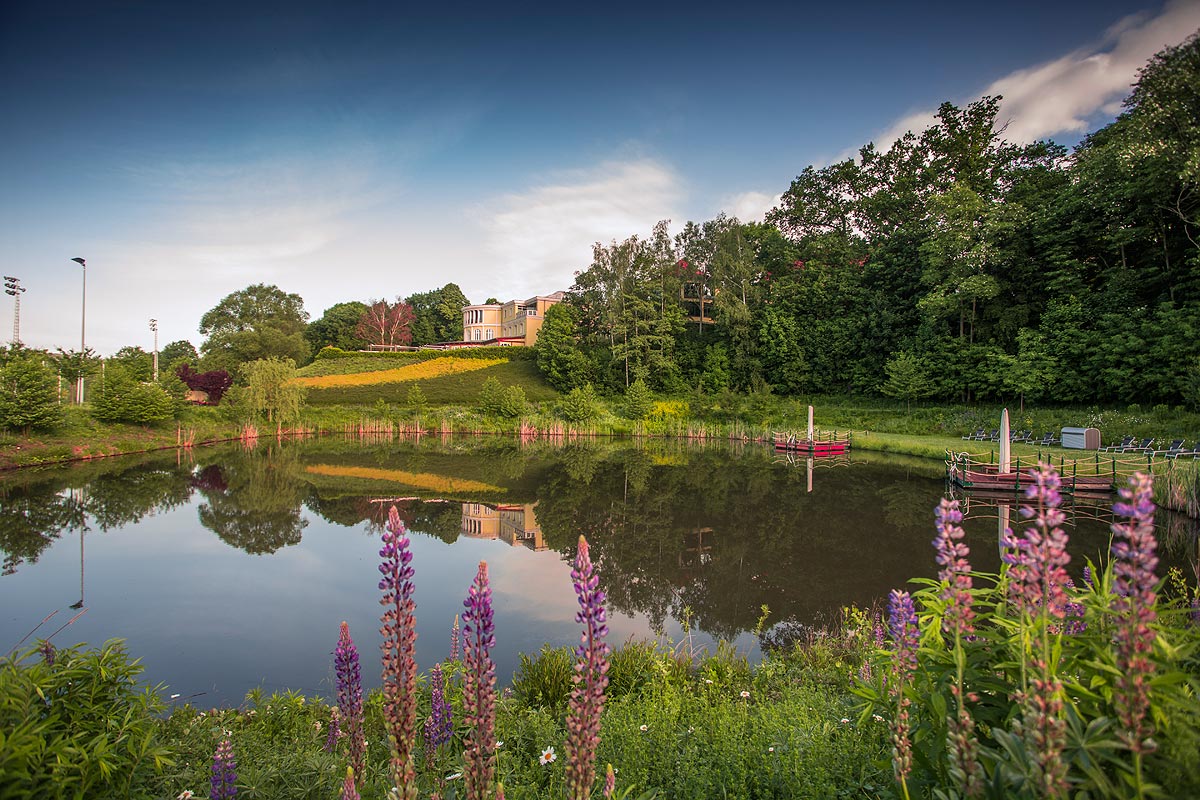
[0,0,1200,355]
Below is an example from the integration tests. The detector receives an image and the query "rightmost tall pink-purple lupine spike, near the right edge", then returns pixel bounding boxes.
[1112,473,1158,756]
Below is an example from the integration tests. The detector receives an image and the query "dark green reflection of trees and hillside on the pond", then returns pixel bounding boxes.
[0,438,1200,639]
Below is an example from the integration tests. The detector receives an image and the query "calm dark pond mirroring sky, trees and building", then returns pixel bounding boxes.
[0,437,1195,706]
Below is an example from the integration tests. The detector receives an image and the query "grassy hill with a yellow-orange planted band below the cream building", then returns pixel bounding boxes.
[298,348,559,405]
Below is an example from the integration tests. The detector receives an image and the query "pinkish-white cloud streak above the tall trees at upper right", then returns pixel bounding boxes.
[875,0,1200,149]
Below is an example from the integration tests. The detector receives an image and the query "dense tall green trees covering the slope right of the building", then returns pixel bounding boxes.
[538,36,1200,403]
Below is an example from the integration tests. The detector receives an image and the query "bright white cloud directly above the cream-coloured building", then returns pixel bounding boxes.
[477,160,683,300]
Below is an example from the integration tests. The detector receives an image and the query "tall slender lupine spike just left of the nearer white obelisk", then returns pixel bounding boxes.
[934,499,983,798]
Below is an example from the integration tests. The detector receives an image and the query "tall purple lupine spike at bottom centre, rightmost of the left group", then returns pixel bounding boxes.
[563,536,608,800]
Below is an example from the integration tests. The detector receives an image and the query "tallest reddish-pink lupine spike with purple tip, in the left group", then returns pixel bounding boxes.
[379,506,427,800]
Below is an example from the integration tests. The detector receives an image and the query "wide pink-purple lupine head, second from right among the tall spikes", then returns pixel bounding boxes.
[1003,464,1070,619]
